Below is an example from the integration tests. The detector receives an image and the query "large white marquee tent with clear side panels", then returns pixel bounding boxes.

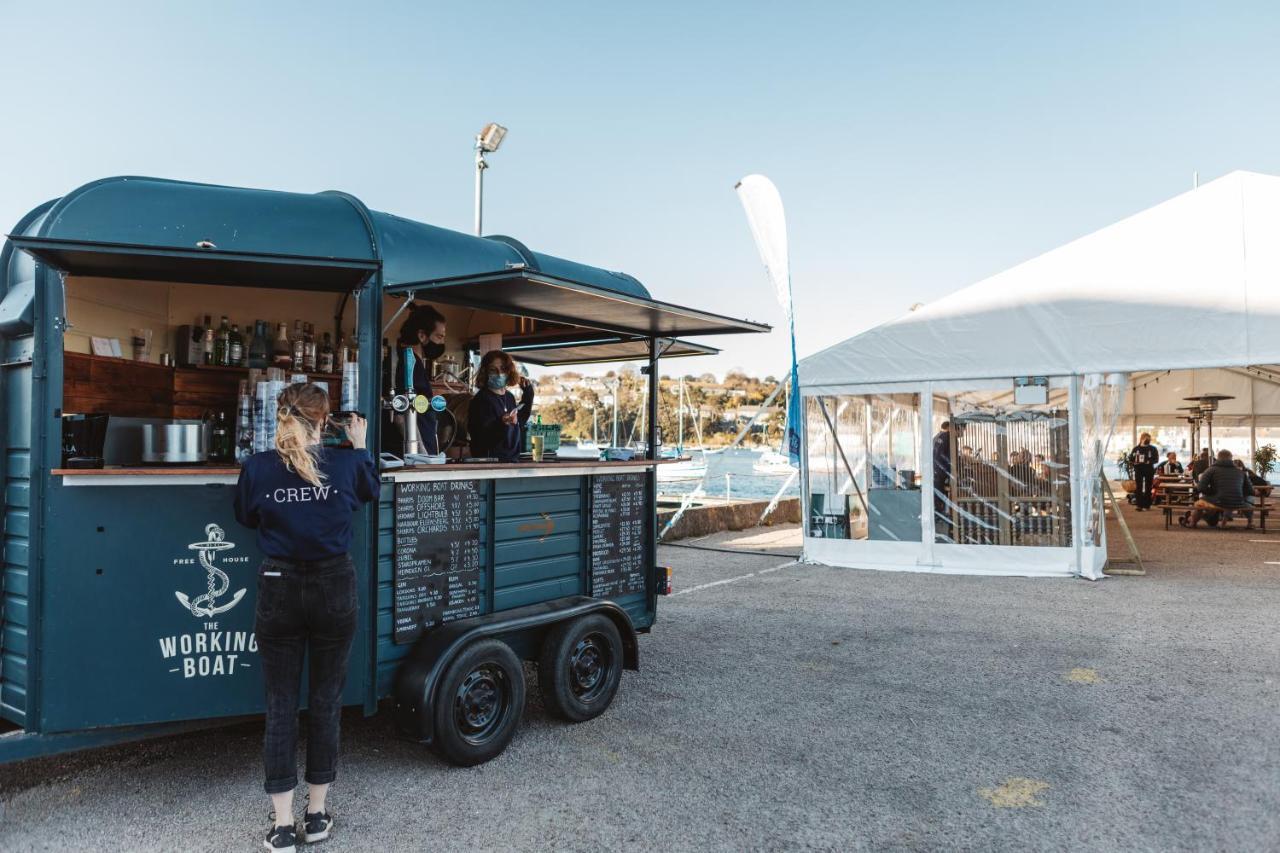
[800,172,1280,578]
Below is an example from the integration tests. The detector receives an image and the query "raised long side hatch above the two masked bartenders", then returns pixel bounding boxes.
[388,270,771,338]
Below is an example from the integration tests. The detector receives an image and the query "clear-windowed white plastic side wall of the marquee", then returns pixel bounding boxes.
[804,374,1125,578]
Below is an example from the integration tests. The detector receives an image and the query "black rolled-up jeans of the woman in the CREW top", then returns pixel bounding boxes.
[253,556,356,794]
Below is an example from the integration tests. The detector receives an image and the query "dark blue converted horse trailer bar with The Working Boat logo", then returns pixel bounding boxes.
[0,178,768,763]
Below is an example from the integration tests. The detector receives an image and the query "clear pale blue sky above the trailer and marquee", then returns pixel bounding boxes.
[0,0,1280,373]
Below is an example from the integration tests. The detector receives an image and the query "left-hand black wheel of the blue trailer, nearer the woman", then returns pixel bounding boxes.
[431,639,525,767]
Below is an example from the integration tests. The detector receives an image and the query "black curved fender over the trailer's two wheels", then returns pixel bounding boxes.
[392,596,640,743]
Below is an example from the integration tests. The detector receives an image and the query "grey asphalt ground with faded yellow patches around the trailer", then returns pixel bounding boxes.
[0,519,1280,853]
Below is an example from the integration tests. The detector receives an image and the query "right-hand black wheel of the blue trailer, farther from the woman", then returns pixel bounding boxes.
[538,613,622,722]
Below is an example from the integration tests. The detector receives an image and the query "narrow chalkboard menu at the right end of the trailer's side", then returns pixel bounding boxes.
[591,474,649,598]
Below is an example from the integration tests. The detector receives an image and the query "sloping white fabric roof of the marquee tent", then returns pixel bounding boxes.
[800,172,1280,388]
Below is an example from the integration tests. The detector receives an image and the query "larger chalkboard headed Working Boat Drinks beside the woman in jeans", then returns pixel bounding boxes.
[394,480,480,643]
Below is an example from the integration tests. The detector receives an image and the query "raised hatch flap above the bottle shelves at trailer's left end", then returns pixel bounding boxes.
[9,234,378,292]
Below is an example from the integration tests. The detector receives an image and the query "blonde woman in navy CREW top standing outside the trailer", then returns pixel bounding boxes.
[236,384,378,850]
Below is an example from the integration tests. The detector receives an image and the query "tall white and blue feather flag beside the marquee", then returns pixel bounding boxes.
[735,174,801,467]
